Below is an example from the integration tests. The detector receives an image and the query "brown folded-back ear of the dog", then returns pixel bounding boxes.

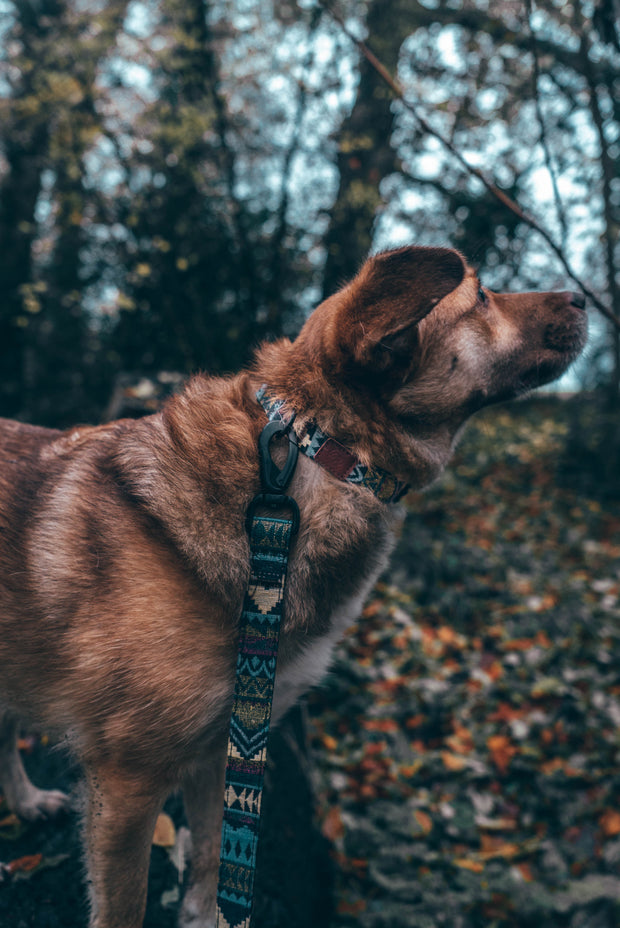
[338,246,466,369]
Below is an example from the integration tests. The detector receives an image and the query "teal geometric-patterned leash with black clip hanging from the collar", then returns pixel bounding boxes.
[215,416,299,928]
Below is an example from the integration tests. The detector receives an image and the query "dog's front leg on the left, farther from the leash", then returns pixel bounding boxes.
[85,767,168,928]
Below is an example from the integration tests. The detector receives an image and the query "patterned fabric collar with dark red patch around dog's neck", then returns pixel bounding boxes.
[256,384,409,503]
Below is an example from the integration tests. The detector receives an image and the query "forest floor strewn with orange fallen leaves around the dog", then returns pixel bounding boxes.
[0,398,620,928]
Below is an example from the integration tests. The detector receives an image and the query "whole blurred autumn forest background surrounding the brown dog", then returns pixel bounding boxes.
[0,0,620,928]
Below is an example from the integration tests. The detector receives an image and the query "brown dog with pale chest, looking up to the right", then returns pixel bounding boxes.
[0,248,586,928]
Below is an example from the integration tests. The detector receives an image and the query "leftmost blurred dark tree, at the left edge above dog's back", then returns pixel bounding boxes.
[0,0,126,421]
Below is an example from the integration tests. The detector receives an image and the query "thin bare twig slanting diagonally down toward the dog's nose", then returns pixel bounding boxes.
[326,6,620,329]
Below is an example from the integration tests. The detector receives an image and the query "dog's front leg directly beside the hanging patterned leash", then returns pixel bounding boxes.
[179,744,226,928]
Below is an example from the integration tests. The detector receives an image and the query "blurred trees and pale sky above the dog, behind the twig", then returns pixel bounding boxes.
[0,0,620,424]
